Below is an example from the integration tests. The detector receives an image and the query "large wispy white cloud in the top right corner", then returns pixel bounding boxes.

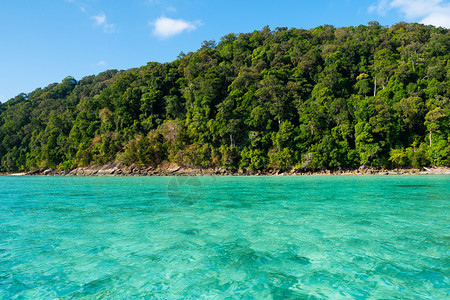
[368,0,450,28]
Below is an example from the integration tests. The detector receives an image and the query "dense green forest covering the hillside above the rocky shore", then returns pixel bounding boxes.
[0,21,450,171]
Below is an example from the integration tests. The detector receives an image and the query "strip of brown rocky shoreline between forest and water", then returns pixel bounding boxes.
[0,163,450,176]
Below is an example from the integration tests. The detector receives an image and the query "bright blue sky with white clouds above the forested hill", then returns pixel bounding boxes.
[0,0,450,102]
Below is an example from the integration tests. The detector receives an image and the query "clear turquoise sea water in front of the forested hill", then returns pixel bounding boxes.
[0,175,450,299]
